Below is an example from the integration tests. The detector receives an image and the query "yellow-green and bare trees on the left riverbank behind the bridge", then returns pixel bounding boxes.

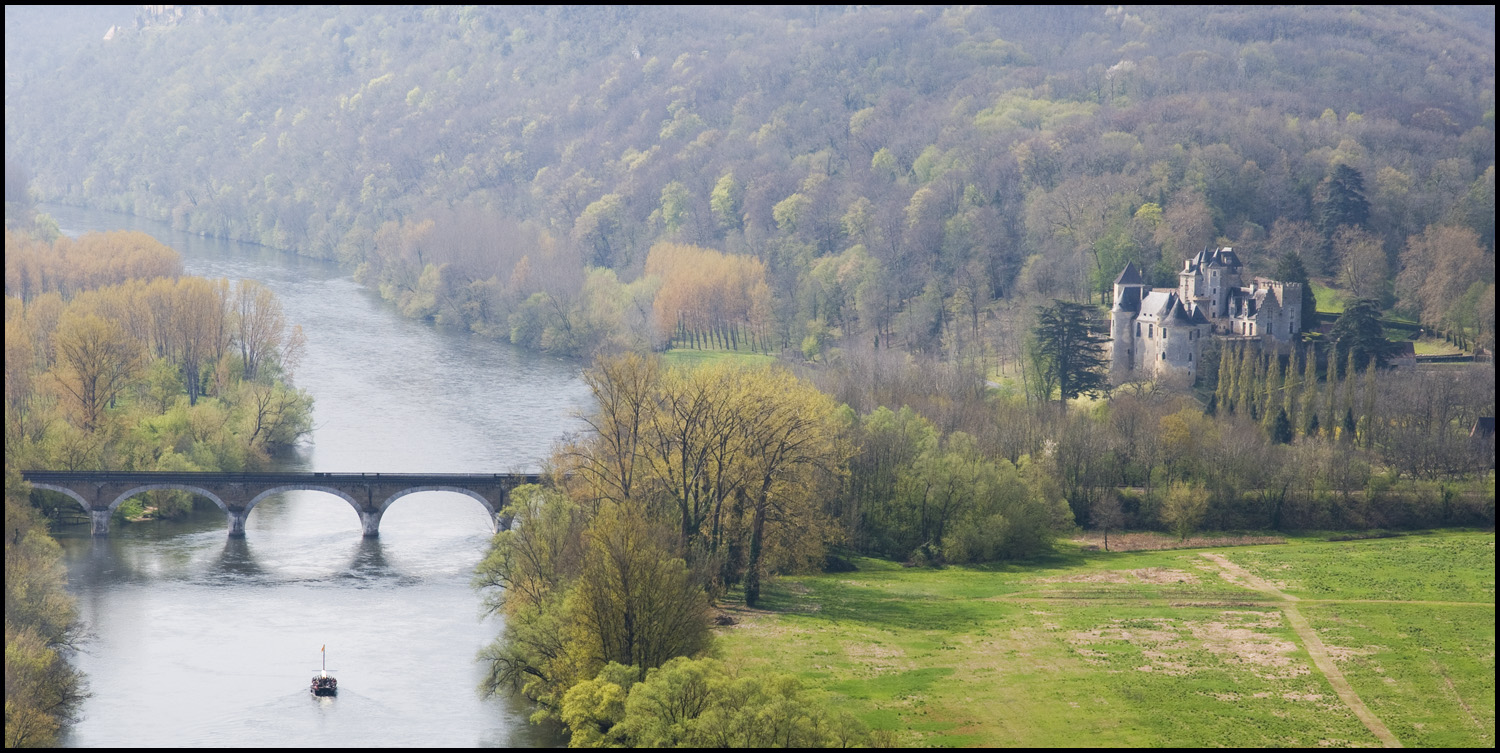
[5,233,312,516]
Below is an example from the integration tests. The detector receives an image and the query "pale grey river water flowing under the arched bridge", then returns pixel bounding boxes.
[44,206,588,747]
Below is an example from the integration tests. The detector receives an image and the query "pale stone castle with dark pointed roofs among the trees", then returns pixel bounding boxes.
[1110,248,1302,384]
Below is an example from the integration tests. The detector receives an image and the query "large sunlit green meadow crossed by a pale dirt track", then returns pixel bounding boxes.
[720,533,1494,747]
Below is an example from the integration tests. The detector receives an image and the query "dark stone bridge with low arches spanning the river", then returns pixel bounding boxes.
[21,471,542,536]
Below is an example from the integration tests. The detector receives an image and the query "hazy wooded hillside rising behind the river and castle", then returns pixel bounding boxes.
[6,6,1494,354]
